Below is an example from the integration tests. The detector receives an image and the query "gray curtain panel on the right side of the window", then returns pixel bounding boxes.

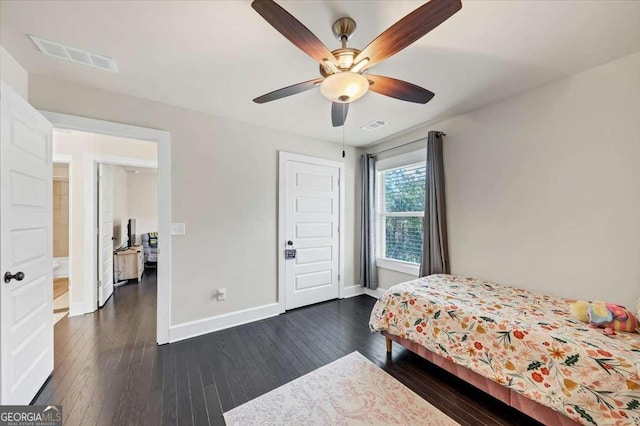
[420,131,450,277]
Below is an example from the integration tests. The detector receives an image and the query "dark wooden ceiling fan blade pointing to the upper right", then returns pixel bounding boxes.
[354,0,462,69]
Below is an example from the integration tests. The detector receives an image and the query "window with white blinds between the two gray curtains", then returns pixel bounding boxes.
[376,150,426,275]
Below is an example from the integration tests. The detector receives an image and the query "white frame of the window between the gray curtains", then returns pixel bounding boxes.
[374,149,427,277]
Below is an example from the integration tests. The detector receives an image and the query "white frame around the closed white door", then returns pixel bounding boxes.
[276,151,345,313]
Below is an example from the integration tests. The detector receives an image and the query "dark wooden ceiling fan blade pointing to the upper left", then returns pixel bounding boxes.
[251,0,337,65]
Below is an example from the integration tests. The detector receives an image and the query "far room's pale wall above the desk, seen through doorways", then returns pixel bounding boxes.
[127,173,158,244]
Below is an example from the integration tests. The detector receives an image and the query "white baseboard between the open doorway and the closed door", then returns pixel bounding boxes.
[169,303,282,343]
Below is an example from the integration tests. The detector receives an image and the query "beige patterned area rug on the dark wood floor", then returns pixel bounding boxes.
[224,352,458,426]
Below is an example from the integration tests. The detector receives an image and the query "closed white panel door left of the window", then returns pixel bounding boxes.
[281,156,340,309]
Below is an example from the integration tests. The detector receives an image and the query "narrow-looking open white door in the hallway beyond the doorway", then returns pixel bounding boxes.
[98,164,113,307]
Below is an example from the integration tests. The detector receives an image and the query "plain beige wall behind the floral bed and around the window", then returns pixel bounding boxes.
[368,53,640,306]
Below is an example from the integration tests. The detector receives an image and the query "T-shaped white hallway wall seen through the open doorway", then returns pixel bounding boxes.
[52,131,157,315]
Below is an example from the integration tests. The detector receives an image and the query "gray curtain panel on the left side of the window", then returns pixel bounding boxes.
[360,154,378,290]
